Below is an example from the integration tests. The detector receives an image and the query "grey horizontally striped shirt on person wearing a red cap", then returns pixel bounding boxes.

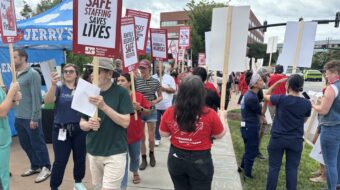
[136,77,161,101]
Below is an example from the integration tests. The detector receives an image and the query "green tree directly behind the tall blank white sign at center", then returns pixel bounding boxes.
[185,0,227,65]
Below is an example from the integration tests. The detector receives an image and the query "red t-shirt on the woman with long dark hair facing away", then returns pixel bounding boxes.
[160,106,224,150]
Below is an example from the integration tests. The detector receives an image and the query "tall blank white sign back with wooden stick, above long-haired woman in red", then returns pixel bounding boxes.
[207,6,250,73]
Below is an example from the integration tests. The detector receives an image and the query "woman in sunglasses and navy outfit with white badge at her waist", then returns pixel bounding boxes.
[45,64,86,190]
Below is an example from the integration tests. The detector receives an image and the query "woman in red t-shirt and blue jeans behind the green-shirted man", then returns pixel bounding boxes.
[117,73,151,186]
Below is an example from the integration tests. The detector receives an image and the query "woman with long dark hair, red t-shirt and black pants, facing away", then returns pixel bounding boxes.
[160,75,225,190]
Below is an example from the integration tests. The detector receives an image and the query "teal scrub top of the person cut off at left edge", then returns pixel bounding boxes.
[0,88,12,149]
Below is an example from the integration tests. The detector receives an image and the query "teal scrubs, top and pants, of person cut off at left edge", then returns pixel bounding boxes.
[0,88,12,190]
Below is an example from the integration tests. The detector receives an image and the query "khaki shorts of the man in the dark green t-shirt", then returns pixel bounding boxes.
[88,153,126,190]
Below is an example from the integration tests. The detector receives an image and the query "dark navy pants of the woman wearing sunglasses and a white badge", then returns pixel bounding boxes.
[50,125,86,190]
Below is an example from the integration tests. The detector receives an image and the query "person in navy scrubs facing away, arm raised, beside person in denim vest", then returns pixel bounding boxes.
[264,74,312,190]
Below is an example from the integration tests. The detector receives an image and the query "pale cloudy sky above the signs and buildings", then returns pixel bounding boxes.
[15,0,340,42]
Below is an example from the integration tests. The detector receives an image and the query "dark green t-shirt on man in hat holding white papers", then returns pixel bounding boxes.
[84,84,134,156]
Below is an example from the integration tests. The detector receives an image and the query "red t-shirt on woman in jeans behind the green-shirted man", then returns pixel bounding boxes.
[127,92,150,144]
